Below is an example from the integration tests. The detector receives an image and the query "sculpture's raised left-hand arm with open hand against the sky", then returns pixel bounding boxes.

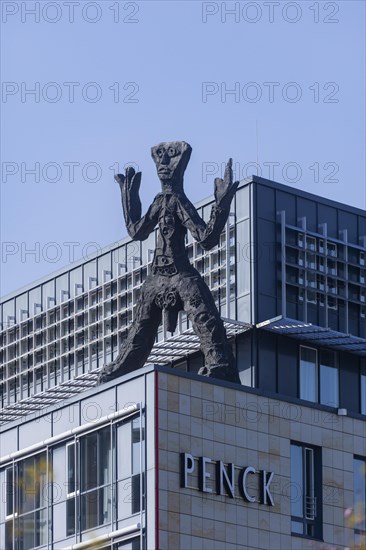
[115,168,160,241]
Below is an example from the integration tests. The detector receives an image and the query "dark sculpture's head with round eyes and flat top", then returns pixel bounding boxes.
[151,141,192,191]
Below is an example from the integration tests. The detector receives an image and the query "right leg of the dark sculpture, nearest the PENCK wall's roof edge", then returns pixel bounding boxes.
[179,273,240,384]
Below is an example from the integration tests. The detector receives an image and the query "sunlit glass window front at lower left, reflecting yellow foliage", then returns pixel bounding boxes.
[0,413,146,550]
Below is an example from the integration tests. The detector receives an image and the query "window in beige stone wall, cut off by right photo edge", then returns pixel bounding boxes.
[353,457,366,548]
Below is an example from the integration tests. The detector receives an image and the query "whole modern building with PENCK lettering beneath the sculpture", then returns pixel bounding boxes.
[0,177,366,550]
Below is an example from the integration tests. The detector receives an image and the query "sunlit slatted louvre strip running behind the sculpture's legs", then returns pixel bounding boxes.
[0,319,252,424]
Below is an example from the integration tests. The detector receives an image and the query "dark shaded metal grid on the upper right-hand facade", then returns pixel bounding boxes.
[281,213,366,338]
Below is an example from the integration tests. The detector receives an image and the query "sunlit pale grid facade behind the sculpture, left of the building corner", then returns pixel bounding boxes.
[0,190,244,407]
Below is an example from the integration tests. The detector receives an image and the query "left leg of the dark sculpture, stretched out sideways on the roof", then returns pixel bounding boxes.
[98,277,162,384]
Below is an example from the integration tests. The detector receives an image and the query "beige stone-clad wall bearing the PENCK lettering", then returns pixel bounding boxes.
[158,372,366,550]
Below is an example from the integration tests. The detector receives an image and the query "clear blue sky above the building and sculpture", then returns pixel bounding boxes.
[0,0,366,296]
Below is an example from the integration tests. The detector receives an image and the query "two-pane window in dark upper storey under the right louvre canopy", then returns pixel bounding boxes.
[299,346,339,407]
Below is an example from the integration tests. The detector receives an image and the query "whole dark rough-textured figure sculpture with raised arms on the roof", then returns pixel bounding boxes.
[99,141,240,383]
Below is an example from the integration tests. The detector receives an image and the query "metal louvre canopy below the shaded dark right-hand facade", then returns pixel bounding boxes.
[257,315,366,357]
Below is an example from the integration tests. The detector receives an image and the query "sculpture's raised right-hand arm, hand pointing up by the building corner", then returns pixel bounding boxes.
[179,159,239,250]
